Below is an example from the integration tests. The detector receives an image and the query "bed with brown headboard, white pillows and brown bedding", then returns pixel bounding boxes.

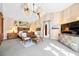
[18,27,42,43]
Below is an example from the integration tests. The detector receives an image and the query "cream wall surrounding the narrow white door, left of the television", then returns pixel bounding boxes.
[41,12,61,40]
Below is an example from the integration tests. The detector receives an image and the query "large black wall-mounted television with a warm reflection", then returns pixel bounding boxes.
[61,21,79,35]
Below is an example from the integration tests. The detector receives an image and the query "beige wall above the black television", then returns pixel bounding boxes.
[60,3,79,24]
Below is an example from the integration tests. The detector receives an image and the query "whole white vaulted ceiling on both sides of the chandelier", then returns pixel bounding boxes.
[3,3,72,20]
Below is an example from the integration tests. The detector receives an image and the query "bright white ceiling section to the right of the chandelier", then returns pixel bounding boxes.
[26,3,73,13]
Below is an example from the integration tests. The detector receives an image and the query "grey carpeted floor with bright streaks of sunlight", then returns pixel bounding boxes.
[0,39,79,56]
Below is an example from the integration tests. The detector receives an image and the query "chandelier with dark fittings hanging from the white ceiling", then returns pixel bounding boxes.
[24,3,40,19]
